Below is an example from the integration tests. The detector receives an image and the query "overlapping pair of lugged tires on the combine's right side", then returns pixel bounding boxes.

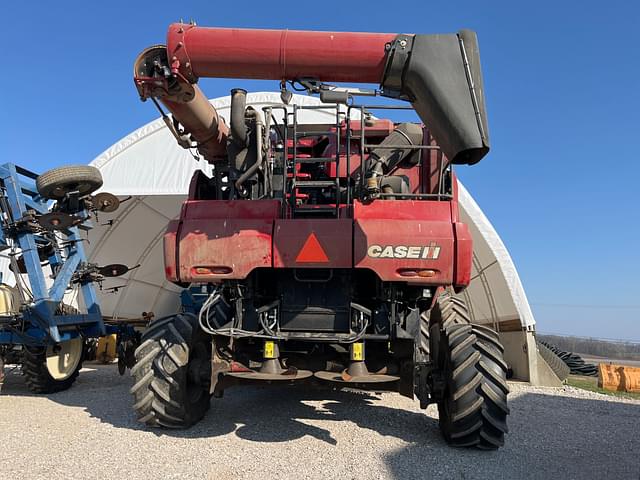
[430,293,509,450]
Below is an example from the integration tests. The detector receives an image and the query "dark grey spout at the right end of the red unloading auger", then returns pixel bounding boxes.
[381,30,489,165]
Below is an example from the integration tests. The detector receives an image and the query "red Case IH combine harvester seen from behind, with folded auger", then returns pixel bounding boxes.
[131,24,509,449]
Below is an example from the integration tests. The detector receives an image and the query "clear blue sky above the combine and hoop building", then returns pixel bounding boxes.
[0,0,640,341]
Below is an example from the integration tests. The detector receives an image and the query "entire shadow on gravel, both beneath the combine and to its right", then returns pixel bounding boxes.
[2,365,640,480]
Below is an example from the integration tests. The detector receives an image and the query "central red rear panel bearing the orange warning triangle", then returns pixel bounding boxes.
[273,219,353,268]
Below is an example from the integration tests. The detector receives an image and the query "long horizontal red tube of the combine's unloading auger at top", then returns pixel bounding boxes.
[167,23,396,83]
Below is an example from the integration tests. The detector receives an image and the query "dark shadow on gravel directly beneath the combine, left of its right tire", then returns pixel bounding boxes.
[3,365,444,445]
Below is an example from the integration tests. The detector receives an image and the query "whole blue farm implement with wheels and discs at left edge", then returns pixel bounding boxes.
[0,164,136,393]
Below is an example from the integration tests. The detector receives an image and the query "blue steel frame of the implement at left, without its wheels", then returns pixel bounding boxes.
[0,163,106,345]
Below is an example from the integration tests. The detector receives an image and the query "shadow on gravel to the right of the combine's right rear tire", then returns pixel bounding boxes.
[384,393,640,480]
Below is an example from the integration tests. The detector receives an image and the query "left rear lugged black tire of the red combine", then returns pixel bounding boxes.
[131,313,211,428]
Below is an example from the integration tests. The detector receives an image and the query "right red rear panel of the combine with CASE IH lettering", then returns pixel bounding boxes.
[353,200,455,285]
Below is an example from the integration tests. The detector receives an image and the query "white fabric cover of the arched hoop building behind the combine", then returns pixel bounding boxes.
[74,93,535,330]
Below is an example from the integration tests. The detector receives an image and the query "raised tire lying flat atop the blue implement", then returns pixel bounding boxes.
[36,165,102,200]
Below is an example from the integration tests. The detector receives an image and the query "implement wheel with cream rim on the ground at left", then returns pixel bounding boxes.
[22,337,84,393]
